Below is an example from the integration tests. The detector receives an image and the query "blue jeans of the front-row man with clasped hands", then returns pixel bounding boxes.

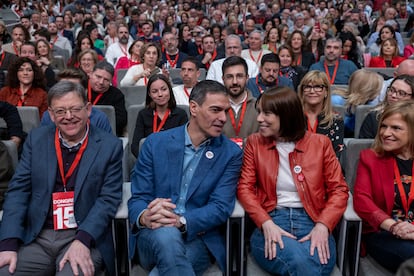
[137,227,211,276]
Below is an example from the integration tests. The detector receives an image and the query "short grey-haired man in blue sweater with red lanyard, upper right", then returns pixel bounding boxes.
[309,38,358,85]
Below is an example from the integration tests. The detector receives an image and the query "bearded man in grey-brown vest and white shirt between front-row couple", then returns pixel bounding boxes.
[222,56,259,148]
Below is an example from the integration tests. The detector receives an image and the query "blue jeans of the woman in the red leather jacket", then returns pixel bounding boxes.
[250,208,336,276]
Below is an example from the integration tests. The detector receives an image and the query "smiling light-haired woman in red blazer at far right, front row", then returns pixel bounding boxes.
[354,100,414,270]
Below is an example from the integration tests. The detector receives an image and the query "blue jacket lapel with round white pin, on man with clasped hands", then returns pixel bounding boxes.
[187,136,222,200]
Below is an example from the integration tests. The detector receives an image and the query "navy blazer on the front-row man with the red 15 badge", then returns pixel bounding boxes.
[0,125,123,275]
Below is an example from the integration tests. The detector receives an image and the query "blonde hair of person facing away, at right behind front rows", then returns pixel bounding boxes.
[346,69,384,113]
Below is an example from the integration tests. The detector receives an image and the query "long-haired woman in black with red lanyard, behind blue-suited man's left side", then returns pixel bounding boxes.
[131,75,188,157]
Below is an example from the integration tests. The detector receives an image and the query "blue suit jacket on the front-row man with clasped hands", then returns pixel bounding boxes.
[128,125,242,269]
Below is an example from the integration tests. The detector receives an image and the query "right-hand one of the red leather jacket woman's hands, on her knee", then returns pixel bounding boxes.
[299,222,331,264]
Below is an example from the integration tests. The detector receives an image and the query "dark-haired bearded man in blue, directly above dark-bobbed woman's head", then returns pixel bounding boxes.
[247,53,295,98]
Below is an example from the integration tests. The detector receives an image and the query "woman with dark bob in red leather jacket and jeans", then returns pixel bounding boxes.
[237,88,348,275]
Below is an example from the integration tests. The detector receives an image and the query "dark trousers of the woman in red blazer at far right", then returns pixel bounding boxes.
[365,231,414,272]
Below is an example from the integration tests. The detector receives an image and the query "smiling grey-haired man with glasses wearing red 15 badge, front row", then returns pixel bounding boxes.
[0,81,122,275]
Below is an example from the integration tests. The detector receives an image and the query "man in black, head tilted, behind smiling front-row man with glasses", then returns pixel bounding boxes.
[87,61,127,136]
